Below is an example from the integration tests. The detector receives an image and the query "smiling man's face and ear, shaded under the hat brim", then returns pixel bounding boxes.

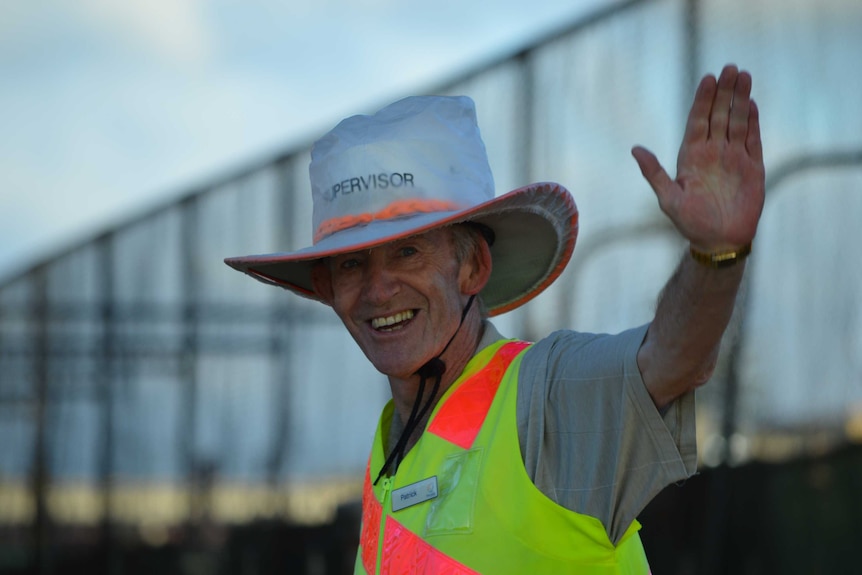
[314,228,490,379]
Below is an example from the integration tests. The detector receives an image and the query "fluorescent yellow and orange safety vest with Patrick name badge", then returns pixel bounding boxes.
[355,341,649,575]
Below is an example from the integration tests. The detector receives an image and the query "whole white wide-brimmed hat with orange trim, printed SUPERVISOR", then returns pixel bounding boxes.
[225,96,578,316]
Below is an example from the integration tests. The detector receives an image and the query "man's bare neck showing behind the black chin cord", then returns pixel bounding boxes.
[389,306,484,449]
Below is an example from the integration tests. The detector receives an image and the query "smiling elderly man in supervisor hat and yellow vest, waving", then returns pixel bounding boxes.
[226,66,764,574]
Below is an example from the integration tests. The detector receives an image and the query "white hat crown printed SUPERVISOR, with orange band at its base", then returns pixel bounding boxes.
[309,96,494,243]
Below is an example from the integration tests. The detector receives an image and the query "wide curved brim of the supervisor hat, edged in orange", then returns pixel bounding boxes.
[224,182,578,316]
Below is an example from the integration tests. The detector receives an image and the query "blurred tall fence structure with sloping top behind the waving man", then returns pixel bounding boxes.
[0,0,862,575]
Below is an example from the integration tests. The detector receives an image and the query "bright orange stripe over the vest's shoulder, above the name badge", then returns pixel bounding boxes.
[428,341,530,449]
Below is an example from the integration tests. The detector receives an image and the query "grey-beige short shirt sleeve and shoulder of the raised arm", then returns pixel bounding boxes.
[517,326,697,544]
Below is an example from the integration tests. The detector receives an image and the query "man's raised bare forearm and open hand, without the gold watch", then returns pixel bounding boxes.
[632,66,765,408]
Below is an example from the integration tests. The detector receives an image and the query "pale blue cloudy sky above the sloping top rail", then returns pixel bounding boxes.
[0,0,611,281]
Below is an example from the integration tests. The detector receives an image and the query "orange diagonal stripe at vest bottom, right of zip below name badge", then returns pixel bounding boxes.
[384,515,479,575]
